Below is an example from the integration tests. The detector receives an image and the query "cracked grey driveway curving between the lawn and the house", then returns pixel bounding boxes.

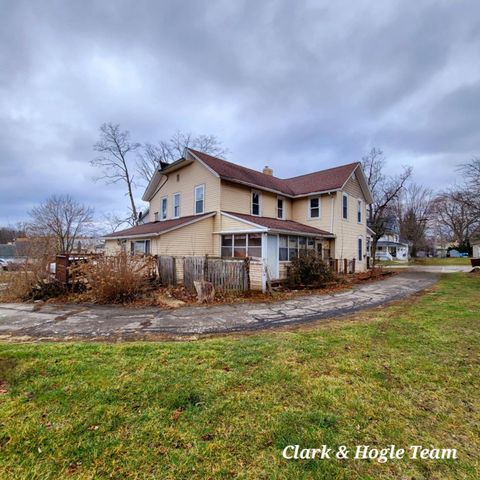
[0,272,438,341]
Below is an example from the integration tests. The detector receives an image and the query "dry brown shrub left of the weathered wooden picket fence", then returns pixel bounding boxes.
[78,253,155,303]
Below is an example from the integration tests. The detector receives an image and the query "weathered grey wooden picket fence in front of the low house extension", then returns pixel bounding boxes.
[158,255,250,292]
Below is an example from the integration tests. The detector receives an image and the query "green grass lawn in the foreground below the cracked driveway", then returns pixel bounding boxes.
[0,274,480,480]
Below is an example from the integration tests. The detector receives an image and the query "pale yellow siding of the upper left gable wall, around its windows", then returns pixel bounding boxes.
[149,161,220,222]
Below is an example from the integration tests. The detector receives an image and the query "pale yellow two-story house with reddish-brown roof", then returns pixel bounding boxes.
[106,148,372,279]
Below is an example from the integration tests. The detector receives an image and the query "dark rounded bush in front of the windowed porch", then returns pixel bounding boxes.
[288,251,333,287]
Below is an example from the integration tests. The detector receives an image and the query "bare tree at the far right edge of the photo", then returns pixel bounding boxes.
[433,190,480,246]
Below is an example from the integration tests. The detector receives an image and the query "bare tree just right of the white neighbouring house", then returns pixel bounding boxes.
[395,183,433,257]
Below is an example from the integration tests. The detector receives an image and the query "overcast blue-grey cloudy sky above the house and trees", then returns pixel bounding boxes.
[0,0,480,225]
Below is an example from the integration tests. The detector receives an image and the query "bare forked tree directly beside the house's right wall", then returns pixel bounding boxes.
[362,147,412,263]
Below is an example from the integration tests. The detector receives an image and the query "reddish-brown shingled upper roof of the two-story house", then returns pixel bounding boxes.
[189,149,359,197]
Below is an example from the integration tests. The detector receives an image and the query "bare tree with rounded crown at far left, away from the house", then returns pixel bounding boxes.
[28,195,93,253]
